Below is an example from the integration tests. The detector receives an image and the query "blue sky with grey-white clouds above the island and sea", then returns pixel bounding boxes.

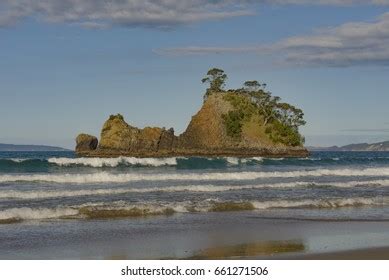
[0,0,389,148]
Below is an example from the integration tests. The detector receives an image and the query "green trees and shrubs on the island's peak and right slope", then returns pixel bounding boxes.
[202,68,306,146]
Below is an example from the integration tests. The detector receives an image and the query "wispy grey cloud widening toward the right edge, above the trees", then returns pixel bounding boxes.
[158,13,389,67]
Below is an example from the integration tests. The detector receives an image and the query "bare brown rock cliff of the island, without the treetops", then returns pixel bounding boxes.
[76,91,308,157]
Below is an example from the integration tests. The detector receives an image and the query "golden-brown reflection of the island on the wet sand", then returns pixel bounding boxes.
[188,240,305,259]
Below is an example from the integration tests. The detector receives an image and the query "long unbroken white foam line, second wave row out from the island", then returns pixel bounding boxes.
[0,168,389,184]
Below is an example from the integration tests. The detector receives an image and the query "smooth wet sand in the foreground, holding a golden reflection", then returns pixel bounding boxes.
[0,211,389,259]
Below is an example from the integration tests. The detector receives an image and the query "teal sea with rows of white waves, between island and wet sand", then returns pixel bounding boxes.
[0,152,389,221]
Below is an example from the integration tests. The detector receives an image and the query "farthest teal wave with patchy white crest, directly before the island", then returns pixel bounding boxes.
[0,156,389,172]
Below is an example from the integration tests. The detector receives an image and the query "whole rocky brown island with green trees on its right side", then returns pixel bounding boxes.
[76,68,308,157]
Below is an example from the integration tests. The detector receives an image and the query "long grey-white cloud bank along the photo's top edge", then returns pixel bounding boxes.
[0,0,389,28]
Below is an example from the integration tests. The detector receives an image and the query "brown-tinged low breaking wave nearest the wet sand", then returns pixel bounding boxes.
[0,197,389,224]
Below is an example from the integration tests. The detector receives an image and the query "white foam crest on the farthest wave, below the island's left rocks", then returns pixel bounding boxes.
[48,157,177,167]
